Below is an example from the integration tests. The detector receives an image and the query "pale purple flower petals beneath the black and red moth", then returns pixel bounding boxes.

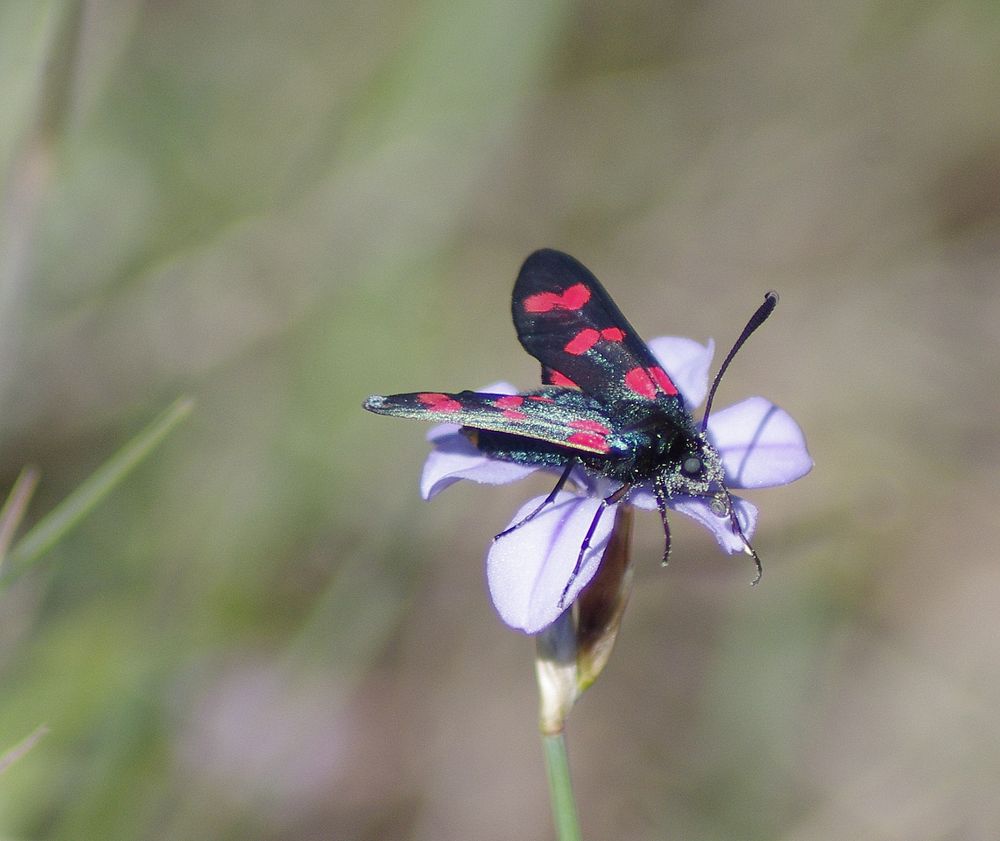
[420,337,813,634]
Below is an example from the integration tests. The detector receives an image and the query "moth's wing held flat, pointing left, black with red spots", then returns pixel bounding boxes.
[364,388,613,454]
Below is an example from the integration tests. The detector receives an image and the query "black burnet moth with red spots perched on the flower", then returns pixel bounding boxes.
[364,249,778,596]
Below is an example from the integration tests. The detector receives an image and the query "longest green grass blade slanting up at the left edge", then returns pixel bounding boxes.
[5,397,194,577]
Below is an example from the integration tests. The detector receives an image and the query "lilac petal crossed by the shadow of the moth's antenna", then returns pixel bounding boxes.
[708,397,813,488]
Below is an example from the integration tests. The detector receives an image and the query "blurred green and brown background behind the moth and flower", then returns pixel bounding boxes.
[0,0,1000,841]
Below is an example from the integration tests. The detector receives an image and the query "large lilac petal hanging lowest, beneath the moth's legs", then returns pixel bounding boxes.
[486,491,615,634]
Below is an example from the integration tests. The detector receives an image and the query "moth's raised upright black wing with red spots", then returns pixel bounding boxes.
[511,248,681,406]
